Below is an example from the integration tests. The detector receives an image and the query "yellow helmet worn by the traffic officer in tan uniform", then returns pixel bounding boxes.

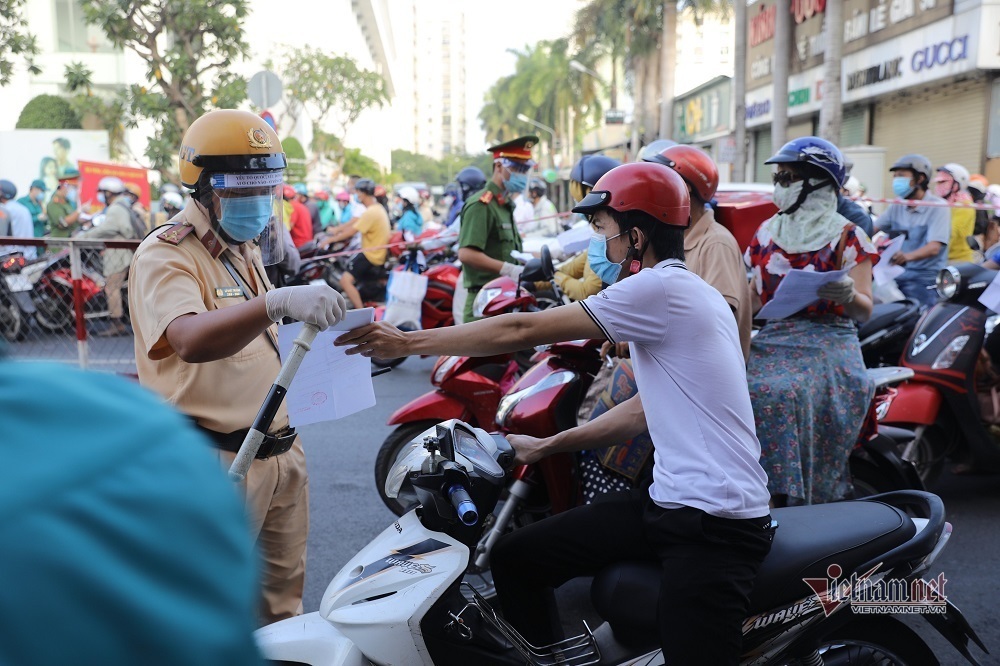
[178,109,287,189]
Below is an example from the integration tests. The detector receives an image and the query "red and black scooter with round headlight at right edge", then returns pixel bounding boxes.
[879,264,1000,486]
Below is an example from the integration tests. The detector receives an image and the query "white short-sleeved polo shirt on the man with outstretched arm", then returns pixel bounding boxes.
[582,260,770,519]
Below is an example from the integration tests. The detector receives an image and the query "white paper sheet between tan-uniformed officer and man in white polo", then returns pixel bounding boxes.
[278,308,375,428]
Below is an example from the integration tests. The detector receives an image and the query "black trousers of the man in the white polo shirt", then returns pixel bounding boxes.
[491,489,772,665]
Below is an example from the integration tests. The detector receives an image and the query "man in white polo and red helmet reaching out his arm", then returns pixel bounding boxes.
[338,162,772,664]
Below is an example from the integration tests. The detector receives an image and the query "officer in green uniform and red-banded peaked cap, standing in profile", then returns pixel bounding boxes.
[458,136,538,322]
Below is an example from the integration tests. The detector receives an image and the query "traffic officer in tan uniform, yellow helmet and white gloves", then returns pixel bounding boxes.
[129,110,346,624]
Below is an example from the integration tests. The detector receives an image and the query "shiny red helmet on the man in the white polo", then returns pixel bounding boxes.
[573,162,691,227]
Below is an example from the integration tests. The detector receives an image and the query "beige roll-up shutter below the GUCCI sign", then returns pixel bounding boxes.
[874,78,989,192]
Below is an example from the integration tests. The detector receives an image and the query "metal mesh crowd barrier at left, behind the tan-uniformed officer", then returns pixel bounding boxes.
[0,236,139,375]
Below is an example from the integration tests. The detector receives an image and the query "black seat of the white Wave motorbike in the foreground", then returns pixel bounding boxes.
[590,501,917,645]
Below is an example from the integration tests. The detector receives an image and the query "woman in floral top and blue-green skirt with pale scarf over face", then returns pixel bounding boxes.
[745,137,878,506]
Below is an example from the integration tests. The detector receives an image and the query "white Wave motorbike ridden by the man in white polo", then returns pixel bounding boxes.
[255,420,986,666]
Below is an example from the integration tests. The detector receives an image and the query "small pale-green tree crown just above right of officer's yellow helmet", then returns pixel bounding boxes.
[276,46,389,146]
